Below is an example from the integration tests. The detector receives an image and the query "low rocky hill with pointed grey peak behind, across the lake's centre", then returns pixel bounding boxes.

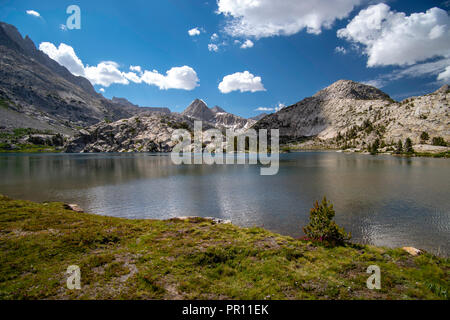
[66,98,256,153]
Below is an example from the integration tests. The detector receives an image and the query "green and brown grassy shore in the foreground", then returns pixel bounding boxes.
[0,196,450,299]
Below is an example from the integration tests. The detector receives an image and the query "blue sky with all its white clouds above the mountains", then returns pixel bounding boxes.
[0,0,450,117]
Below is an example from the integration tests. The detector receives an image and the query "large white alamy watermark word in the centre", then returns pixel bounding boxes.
[171,121,280,176]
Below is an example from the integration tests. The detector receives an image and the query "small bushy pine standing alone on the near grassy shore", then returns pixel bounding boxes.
[303,197,351,245]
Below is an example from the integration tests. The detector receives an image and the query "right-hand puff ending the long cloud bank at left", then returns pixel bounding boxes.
[141,66,200,90]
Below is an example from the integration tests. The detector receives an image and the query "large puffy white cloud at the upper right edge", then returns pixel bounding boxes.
[337,3,450,67]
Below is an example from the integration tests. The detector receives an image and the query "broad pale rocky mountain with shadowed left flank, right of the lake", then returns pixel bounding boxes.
[254,80,450,148]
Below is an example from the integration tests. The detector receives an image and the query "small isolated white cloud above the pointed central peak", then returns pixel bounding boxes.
[219,71,266,93]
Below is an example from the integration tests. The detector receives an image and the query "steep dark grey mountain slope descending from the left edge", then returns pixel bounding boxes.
[0,22,149,135]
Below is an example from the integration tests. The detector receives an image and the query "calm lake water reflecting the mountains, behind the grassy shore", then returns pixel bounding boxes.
[0,152,450,256]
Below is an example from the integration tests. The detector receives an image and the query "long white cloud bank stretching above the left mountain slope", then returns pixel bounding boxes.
[39,42,199,90]
